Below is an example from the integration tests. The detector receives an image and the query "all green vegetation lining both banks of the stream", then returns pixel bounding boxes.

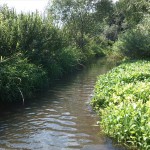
[0,0,150,150]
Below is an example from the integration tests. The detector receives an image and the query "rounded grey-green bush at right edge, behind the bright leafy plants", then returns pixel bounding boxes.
[113,16,150,58]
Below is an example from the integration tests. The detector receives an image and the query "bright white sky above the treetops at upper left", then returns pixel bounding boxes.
[0,0,117,13]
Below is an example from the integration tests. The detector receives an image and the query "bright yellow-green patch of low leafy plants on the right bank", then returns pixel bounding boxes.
[91,61,150,150]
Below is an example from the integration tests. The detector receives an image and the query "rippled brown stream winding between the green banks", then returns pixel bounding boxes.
[0,59,123,150]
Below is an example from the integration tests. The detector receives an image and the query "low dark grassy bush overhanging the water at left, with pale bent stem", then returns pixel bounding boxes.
[0,56,48,103]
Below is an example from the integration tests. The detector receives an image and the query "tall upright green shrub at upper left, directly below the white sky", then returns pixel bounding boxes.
[0,6,65,65]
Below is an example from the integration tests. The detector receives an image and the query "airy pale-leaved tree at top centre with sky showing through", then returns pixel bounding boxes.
[48,0,93,51]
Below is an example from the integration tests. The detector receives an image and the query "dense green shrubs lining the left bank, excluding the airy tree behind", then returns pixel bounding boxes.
[0,6,99,102]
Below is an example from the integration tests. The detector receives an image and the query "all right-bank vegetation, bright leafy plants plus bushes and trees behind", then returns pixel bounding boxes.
[91,0,150,150]
